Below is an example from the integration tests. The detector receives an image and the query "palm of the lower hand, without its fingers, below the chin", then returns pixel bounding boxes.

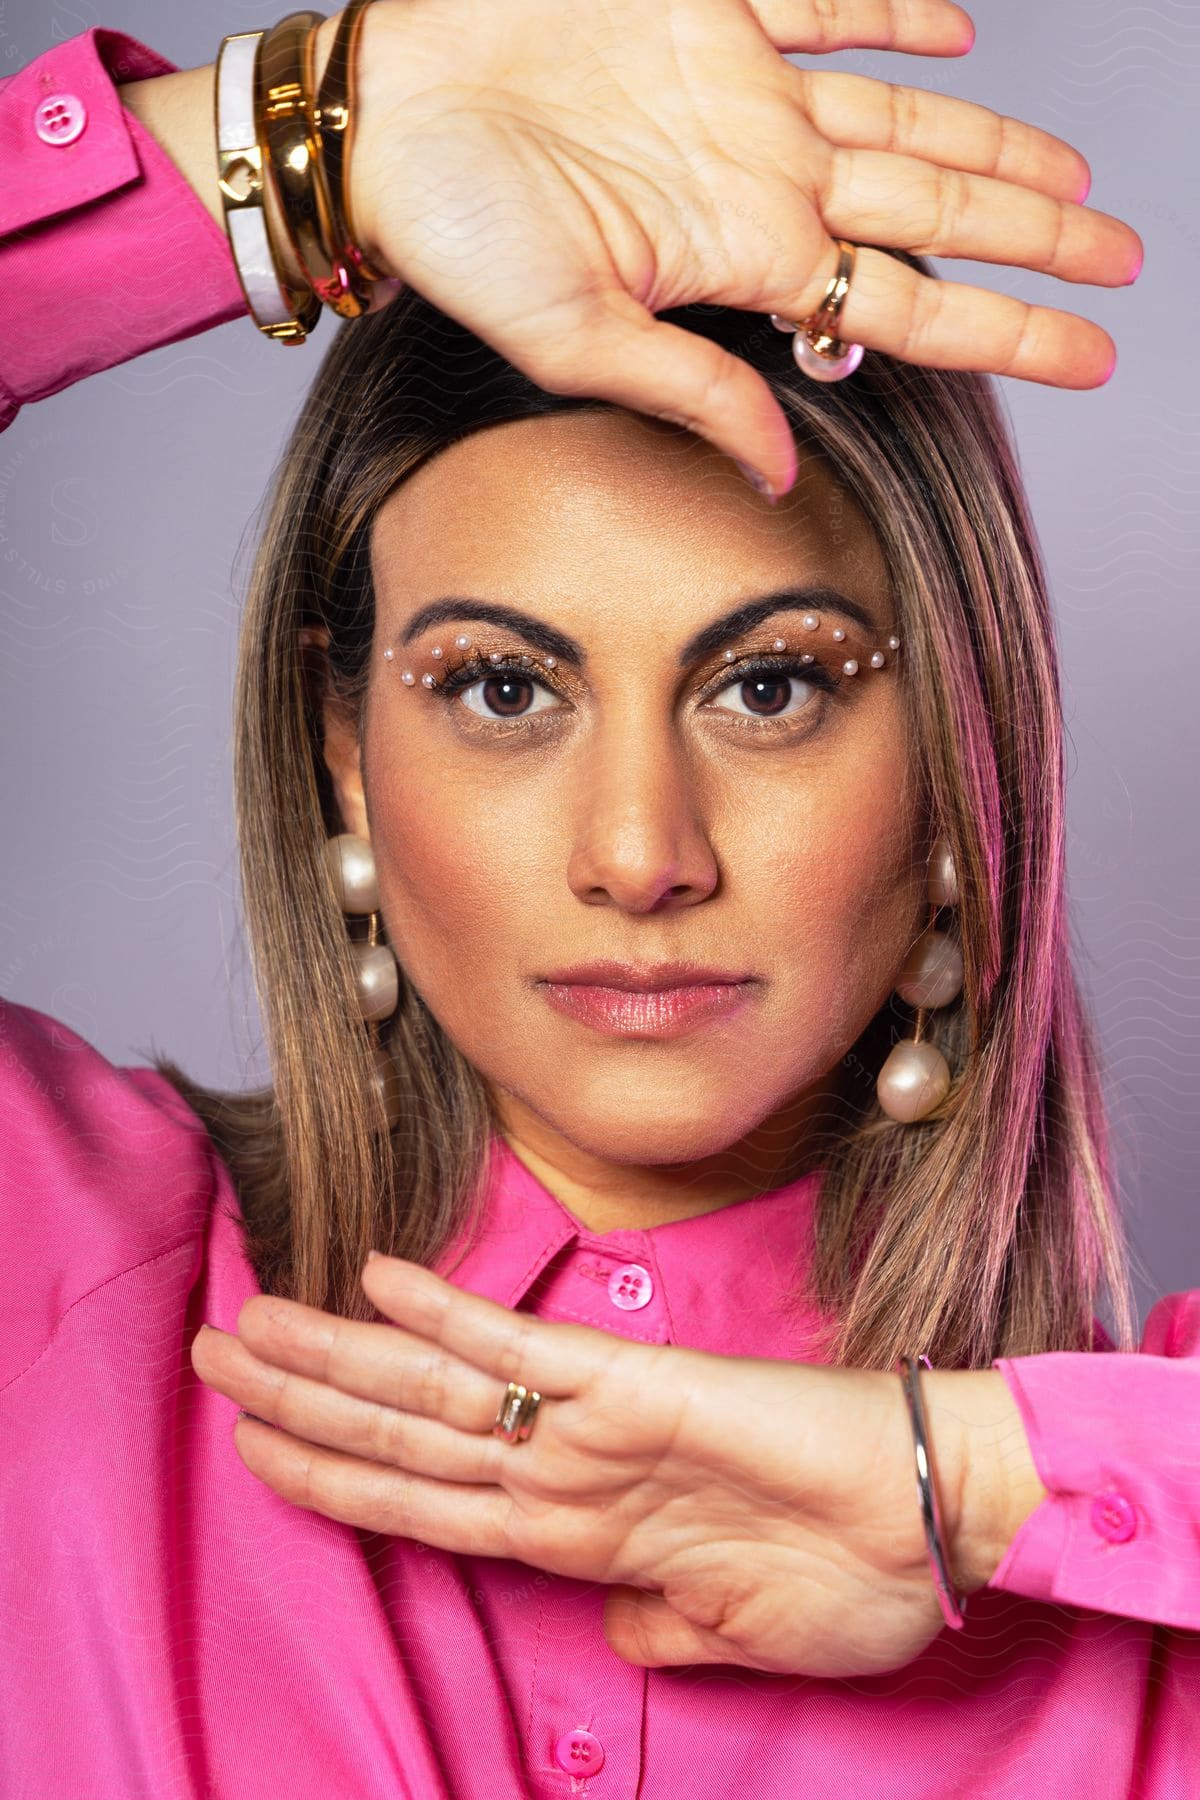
[492,1343,941,1676]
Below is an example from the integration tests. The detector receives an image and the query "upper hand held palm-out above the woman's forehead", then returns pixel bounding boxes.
[351,0,1142,490]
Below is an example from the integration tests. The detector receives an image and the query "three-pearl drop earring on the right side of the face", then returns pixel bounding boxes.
[874,837,963,1125]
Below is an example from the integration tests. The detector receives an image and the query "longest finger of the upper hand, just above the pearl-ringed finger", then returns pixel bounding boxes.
[817,149,1142,288]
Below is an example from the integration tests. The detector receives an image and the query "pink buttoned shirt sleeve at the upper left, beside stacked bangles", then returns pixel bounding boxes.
[0,27,246,430]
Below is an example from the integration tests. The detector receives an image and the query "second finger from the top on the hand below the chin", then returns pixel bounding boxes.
[230,1294,500,1431]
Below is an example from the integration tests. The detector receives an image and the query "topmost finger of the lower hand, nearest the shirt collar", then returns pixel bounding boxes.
[362,1256,630,1399]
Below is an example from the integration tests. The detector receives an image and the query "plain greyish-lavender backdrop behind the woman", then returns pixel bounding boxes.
[0,0,1200,1316]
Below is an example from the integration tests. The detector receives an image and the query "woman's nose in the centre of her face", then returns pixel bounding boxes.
[567,716,720,913]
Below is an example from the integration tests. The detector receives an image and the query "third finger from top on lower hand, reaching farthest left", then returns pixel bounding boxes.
[194,1327,506,1483]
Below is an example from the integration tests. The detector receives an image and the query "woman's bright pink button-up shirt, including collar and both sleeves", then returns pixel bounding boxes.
[0,31,1200,1800]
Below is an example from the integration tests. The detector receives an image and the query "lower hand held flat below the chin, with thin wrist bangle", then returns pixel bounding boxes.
[193,1256,1036,1676]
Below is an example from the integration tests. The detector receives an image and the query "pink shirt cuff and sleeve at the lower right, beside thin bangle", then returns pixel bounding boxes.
[988,1289,1200,1631]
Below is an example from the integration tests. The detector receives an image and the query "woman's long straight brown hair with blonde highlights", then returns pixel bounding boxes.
[155,252,1133,1368]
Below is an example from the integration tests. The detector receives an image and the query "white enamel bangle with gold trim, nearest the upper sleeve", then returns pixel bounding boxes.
[214,31,320,344]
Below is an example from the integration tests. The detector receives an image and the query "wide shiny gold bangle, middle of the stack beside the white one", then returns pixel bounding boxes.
[255,11,367,319]
